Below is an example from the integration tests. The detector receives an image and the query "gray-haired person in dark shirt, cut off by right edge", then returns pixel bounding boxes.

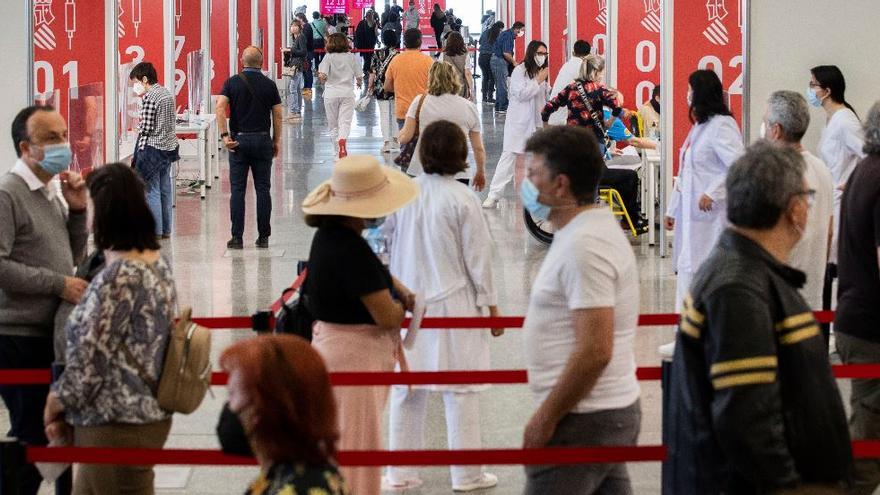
[834,102,880,494]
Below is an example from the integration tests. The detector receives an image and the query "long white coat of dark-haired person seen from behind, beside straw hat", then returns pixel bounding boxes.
[382,174,498,392]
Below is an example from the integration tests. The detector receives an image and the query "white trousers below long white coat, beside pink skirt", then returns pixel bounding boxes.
[388,386,483,486]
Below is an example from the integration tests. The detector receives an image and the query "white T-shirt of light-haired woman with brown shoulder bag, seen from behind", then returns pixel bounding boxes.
[406,94,480,179]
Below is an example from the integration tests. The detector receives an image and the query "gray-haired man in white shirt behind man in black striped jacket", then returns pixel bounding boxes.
[761,91,834,326]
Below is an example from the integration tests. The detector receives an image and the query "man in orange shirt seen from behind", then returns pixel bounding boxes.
[385,29,434,129]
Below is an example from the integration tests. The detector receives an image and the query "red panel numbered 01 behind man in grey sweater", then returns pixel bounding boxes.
[33,0,109,170]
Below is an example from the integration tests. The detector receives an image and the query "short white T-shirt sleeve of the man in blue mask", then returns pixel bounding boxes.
[560,242,618,311]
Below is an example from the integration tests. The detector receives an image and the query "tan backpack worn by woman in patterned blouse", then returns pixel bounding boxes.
[122,308,211,414]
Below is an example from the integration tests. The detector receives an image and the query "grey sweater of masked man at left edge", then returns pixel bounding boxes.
[0,173,89,337]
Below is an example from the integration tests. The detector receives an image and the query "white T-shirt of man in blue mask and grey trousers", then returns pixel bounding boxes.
[523,208,640,413]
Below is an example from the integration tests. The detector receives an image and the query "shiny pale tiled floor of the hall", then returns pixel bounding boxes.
[25,81,675,495]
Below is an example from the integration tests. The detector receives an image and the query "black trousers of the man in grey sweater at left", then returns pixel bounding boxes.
[0,335,55,495]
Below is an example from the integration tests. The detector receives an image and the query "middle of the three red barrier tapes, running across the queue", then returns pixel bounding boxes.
[0,364,880,387]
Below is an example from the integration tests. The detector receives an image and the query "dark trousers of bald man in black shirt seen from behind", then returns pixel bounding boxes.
[229,132,274,238]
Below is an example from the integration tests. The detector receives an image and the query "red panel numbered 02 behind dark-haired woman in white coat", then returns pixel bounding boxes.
[663,0,743,173]
